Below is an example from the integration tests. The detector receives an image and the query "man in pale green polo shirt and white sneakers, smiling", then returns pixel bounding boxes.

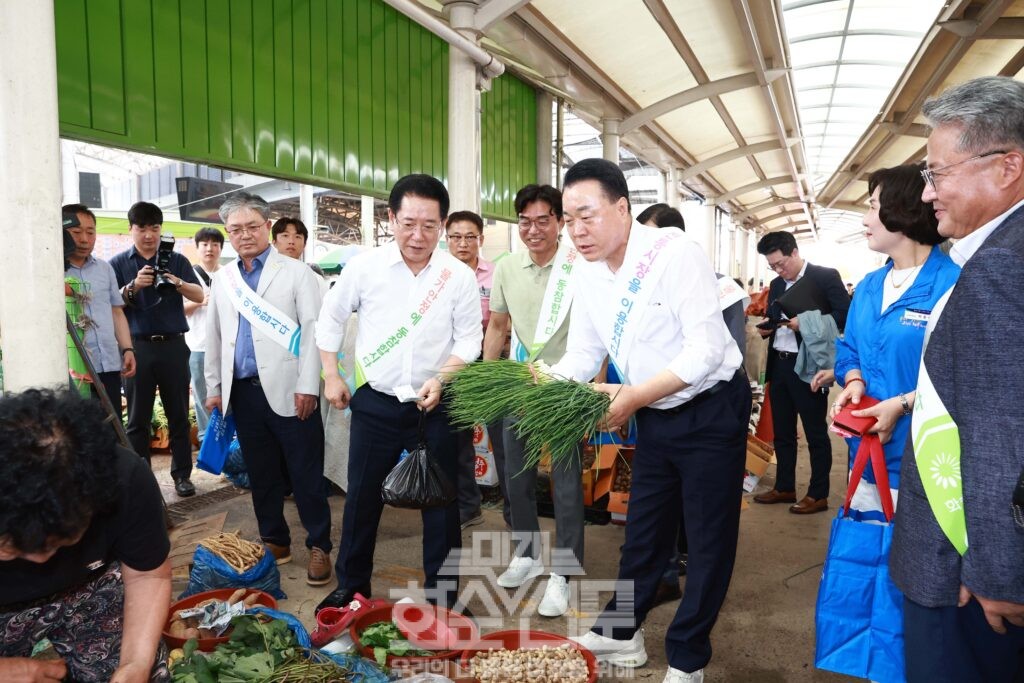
[483,185,583,616]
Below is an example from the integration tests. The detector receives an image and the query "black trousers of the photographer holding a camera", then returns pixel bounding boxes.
[125,337,191,479]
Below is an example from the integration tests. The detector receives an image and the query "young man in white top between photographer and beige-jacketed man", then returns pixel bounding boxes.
[184,227,224,442]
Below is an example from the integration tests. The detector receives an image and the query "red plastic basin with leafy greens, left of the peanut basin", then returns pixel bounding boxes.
[348,603,480,667]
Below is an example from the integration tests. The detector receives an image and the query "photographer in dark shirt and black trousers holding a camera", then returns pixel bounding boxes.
[111,202,203,497]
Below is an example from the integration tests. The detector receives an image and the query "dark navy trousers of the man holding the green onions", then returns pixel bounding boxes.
[593,373,751,672]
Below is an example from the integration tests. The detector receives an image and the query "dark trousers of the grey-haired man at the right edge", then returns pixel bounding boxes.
[903,597,1024,683]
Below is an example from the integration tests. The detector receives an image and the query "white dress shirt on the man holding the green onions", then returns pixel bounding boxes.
[551,221,742,409]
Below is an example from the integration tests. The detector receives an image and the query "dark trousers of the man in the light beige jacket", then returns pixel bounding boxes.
[231,379,331,553]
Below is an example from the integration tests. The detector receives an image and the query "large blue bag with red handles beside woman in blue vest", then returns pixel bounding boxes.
[814,434,906,683]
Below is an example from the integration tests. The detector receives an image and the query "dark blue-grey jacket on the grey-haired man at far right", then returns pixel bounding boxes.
[890,204,1024,607]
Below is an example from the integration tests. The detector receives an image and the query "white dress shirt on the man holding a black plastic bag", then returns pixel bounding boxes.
[316,243,483,395]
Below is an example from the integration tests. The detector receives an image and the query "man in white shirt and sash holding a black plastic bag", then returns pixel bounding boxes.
[316,174,483,611]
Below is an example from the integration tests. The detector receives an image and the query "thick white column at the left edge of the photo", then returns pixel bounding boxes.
[0,2,68,391]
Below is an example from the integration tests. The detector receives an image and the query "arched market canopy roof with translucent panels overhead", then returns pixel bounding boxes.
[415,0,1024,239]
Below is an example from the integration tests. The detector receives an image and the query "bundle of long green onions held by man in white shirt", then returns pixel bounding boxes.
[447,360,611,469]
